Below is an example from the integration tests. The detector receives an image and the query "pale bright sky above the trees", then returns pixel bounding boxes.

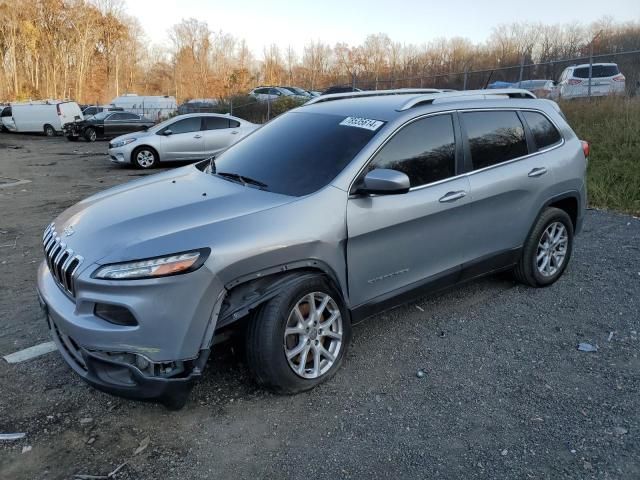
[126,0,640,57]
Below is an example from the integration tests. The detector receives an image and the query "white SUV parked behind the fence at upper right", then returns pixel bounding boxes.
[558,63,625,100]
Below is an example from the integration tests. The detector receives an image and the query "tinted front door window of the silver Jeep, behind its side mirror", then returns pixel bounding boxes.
[368,115,456,187]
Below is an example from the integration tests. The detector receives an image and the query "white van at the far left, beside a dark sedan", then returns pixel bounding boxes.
[11,100,84,137]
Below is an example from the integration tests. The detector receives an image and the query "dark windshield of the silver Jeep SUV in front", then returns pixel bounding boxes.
[215,112,382,196]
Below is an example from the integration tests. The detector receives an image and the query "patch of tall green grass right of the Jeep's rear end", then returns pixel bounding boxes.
[561,97,640,215]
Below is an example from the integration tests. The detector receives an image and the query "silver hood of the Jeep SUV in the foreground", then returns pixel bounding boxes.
[55,165,295,267]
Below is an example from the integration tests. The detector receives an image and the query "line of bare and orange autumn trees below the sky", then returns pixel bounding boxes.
[0,0,640,103]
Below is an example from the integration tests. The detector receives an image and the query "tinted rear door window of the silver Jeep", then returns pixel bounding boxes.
[462,111,529,170]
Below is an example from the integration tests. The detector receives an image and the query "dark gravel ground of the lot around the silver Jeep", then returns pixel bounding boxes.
[0,134,640,479]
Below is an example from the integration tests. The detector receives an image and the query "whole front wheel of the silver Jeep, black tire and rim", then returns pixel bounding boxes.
[246,276,351,394]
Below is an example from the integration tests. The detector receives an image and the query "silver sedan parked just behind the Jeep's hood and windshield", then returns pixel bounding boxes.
[109,113,259,168]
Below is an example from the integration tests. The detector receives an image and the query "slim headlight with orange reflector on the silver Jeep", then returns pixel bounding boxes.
[92,248,209,280]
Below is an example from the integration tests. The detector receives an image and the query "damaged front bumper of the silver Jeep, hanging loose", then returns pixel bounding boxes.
[37,264,223,408]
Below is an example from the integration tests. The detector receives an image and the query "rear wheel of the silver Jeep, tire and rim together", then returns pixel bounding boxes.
[514,208,573,287]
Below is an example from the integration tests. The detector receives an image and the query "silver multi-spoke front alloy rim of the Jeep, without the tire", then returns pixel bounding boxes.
[284,292,343,379]
